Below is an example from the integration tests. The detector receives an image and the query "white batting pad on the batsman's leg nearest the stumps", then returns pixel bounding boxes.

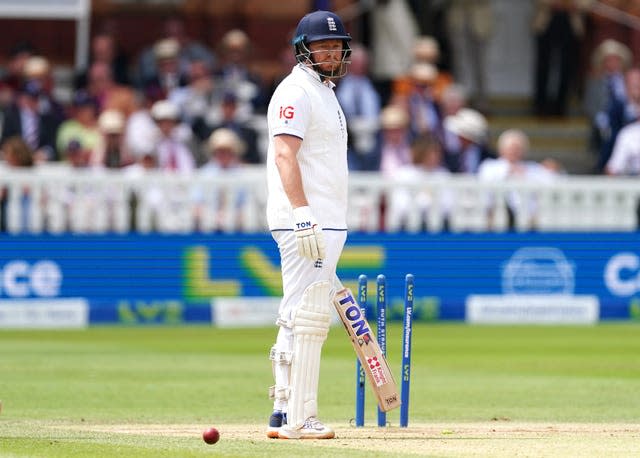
[287,281,331,428]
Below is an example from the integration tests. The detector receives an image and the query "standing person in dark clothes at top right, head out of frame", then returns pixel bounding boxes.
[533,0,586,116]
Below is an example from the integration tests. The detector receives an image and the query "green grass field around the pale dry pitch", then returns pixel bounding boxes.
[0,324,640,457]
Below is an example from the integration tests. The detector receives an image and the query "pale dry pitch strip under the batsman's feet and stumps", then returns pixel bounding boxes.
[56,421,640,457]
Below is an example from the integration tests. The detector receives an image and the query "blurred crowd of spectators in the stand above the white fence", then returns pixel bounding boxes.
[0,0,640,231]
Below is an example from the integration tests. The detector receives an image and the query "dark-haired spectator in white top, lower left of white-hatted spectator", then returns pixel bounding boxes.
[385,135,451,232]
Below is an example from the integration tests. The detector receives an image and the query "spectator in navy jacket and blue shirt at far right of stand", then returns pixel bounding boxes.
[584,39,632,172]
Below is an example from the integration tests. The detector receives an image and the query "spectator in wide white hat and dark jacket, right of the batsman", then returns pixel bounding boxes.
[444,108,495,174]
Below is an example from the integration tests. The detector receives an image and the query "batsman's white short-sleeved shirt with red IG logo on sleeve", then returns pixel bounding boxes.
[267,64,348,230]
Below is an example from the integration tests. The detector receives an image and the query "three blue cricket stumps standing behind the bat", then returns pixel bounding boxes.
[355,274,414,428]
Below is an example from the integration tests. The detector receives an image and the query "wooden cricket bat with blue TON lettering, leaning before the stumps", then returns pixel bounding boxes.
[333,288,400,412]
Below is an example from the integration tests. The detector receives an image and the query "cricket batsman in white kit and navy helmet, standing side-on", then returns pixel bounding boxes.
[267,11,351,439]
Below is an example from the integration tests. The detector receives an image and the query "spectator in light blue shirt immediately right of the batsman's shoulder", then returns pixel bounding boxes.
[336,43,381,170]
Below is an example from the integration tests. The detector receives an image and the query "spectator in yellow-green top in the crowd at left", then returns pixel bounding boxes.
[56,91,102,159]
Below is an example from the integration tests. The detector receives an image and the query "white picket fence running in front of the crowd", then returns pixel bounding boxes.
[0,166,640,234]
